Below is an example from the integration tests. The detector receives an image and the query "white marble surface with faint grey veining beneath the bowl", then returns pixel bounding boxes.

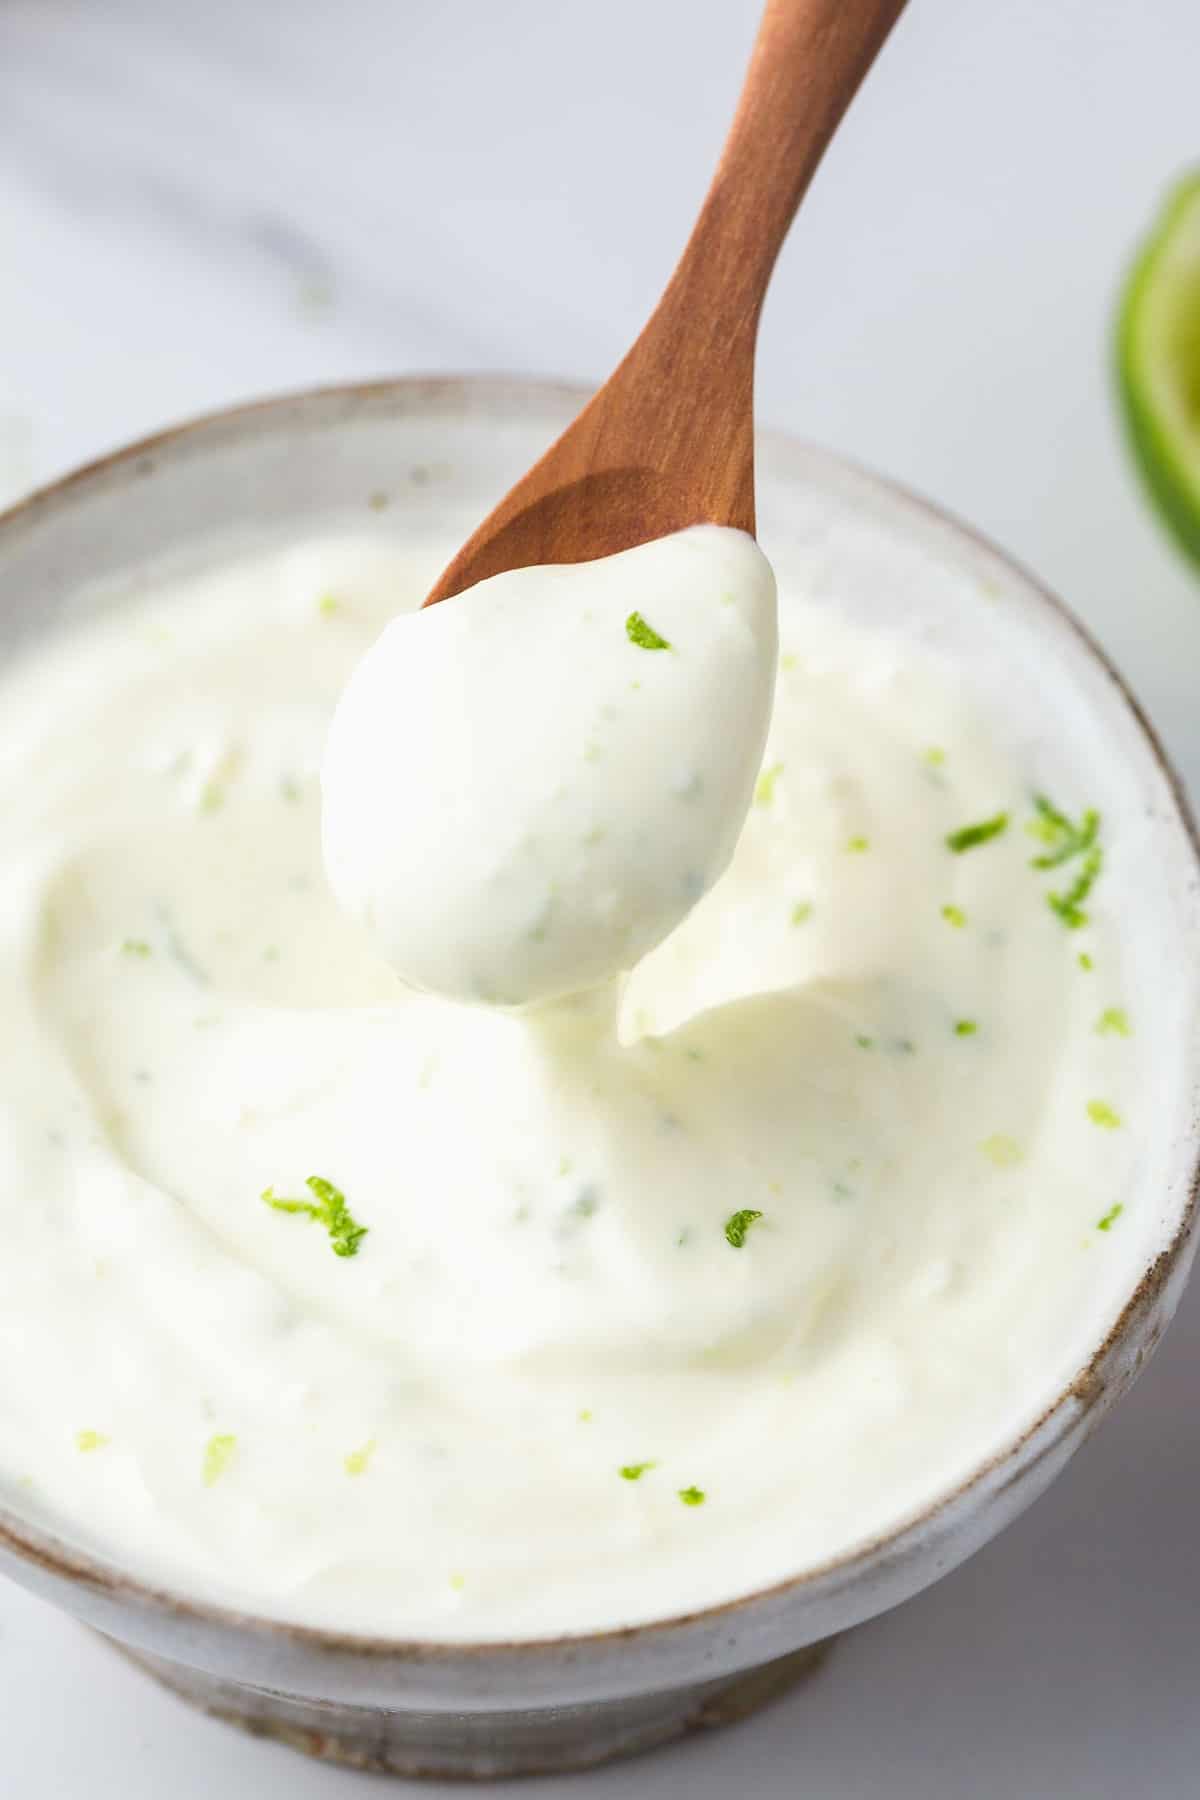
[0,0,1200,1800]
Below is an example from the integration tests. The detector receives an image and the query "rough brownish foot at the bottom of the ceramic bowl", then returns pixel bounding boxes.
[110,1638,837,1780]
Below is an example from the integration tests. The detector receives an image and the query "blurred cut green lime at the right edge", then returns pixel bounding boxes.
[1117,169,1200,565]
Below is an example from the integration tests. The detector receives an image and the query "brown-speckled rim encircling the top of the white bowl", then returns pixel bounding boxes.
[0,371,1200,1665]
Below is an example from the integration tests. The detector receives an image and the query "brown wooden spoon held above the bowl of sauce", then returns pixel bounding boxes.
[425,0,905,607]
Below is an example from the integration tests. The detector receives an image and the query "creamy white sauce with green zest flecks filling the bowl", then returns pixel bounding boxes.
[0,538,1144,1638]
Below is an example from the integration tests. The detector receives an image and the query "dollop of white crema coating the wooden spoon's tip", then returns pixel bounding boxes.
[322,526,777,1006]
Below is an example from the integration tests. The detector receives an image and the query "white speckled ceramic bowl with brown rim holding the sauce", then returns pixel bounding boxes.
[0,378,1200,1778]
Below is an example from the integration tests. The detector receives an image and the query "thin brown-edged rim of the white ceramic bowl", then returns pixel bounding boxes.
[0,371,1200,1663]
